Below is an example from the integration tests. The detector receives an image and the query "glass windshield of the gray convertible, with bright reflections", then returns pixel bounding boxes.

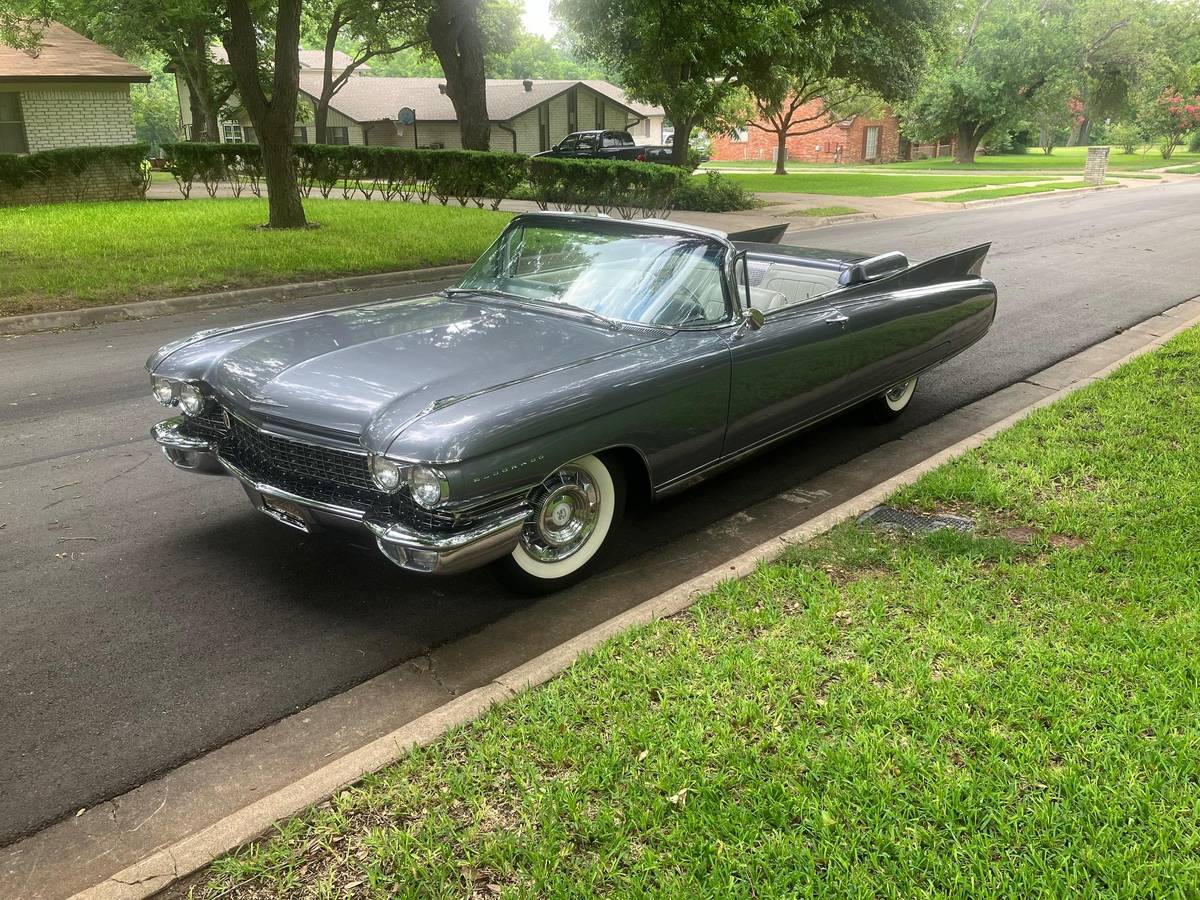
[458,223,726,326]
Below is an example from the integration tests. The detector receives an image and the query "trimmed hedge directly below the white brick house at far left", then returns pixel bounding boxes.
[0,144,150,200]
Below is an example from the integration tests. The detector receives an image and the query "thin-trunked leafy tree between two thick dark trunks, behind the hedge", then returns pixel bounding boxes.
[305,0,428,144]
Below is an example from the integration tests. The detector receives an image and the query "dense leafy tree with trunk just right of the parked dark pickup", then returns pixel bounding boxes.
[554,0,803,166]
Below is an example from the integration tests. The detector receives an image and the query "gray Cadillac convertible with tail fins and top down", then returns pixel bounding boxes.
[146,212,996,593]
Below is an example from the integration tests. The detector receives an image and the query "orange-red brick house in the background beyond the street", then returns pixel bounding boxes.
[712,100,908,163]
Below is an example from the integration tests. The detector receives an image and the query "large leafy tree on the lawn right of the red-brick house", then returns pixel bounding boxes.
[902,0,1078,163]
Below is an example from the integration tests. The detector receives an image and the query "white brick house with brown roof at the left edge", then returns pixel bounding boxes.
[0,23,150,154]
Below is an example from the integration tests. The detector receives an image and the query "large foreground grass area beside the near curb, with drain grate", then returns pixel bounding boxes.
[194,330,1200,899]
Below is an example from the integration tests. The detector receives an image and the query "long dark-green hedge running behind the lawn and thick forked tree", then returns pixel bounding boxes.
[163,143,688,218]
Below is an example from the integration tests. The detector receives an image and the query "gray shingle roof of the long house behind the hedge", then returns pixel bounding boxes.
[300,72,661,122]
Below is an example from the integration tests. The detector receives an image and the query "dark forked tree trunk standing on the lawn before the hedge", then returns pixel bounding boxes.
[222,0,307,228]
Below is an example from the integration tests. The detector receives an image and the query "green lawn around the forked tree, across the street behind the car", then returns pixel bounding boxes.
[0,198,509,316]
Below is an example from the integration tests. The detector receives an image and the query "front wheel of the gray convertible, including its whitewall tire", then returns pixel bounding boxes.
[492,456,625,594]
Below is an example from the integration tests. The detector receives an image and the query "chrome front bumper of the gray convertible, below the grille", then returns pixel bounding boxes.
[150,418,529,575]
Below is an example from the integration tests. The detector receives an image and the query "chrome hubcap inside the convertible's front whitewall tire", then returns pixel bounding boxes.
[521,466,600,563]
